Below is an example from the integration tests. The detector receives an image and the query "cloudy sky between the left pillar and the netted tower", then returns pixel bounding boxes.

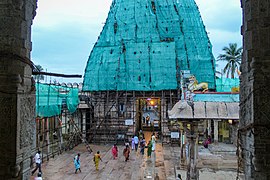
[32,0,111,82]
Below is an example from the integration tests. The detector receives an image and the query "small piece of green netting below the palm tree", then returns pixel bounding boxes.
[216,78,240,92]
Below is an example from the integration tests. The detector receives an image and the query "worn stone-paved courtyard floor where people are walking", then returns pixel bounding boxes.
[31,143,241,180]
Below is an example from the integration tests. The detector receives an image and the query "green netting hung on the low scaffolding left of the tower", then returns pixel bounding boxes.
[36,83,79,117]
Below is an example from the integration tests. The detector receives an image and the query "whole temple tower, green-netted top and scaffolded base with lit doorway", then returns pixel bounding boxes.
[83,0,215,142]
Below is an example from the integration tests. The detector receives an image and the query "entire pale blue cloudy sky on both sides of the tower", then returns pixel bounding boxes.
[31,0,242,83]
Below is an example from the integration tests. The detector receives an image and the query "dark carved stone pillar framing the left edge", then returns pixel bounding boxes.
[0,0,36,180]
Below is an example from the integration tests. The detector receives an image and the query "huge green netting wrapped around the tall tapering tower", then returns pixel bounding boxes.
[83,0,215,91]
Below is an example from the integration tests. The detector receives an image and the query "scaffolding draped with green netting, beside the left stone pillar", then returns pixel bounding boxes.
[36,83,89,160]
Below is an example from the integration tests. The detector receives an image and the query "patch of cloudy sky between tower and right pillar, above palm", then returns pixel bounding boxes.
[196,0,242,60]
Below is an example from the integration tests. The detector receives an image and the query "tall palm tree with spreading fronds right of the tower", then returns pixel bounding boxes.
[217,43,243,78]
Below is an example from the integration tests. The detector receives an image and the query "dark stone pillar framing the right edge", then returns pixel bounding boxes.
[242,0,270,180]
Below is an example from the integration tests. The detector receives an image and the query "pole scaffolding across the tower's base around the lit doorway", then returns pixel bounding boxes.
[86,90,180,144]
